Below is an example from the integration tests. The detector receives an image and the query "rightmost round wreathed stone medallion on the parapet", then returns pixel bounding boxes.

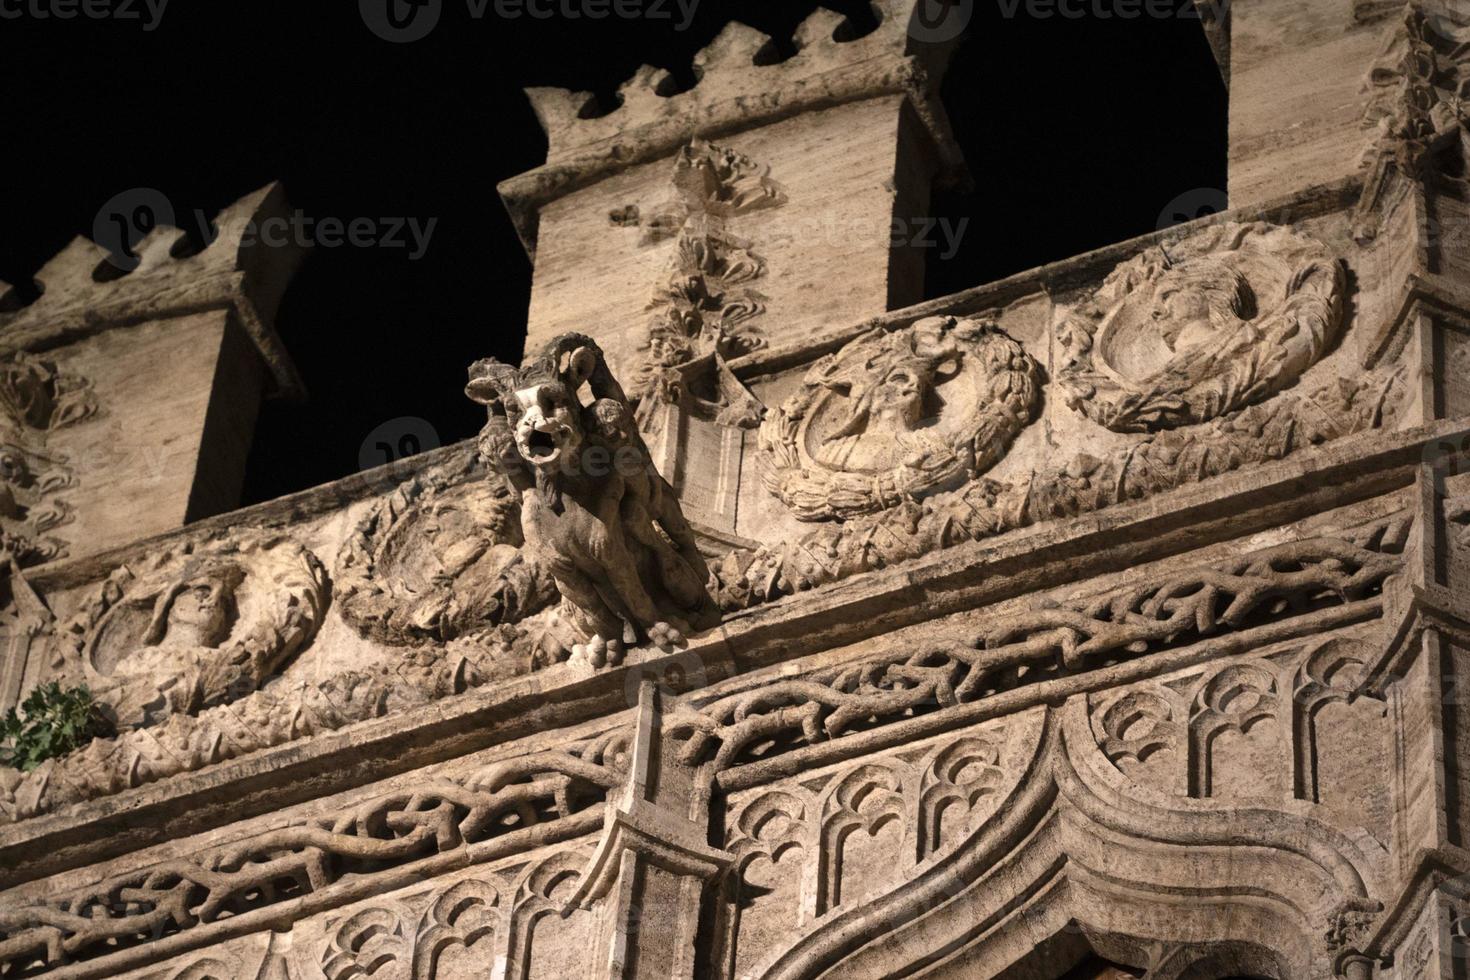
[1057,222,1344,432]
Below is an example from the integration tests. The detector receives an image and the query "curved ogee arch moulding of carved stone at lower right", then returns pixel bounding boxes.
[742,698,1380,980]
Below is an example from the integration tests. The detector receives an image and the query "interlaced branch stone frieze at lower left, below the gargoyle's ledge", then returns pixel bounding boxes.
[0,730,628,976]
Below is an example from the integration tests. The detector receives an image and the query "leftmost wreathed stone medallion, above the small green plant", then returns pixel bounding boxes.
[59,532,328,726]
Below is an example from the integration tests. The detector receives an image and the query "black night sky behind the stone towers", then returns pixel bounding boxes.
[0,0,1226,502]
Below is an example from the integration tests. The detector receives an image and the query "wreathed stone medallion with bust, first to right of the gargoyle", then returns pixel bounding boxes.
[760,316,1039,520]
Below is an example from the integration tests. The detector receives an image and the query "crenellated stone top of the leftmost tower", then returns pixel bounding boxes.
[0,184,306,400]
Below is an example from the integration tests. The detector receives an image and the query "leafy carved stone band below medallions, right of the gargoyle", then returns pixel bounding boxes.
[711,369,1405,610]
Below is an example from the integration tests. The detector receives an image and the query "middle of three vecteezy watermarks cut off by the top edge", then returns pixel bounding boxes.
[357,0,700,44]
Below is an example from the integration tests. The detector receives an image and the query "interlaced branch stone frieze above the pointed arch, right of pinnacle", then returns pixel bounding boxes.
[664,516,1411,799]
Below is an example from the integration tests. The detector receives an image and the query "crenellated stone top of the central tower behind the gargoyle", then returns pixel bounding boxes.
[498,0,969,257]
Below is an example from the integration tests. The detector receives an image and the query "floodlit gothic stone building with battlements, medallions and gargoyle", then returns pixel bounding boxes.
[0,0,1470,980]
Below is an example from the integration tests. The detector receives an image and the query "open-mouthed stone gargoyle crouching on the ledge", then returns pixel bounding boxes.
[465,334,719,666]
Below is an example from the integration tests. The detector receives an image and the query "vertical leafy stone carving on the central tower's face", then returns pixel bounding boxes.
[610,140,785,428]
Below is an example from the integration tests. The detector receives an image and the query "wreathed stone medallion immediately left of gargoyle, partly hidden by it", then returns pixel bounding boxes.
[335,455,556,644]
